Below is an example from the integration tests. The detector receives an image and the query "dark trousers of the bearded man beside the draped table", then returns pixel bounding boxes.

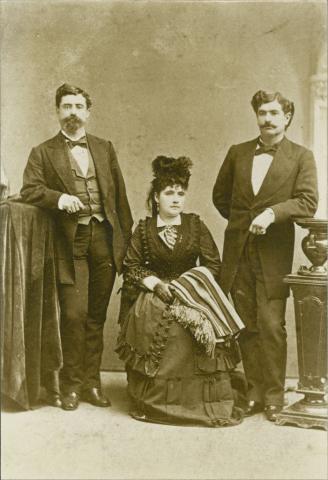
[59,218,116,393]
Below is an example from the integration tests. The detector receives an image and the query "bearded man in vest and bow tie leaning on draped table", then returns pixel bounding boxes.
[21,84,133,410]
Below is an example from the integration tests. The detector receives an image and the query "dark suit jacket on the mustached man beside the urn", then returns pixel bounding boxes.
[213,137,318,298]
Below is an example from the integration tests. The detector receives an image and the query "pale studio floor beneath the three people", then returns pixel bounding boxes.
[1,372,327,480]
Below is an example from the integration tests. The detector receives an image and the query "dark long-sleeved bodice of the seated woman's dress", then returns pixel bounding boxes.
[124,213,221,288]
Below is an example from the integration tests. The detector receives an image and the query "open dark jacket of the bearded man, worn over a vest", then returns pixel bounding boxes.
[21,134,133,284]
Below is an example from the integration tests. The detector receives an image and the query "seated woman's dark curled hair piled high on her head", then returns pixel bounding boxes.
[147,156,192,216]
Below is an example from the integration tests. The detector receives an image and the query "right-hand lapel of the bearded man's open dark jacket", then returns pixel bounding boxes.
[87,134,115,198]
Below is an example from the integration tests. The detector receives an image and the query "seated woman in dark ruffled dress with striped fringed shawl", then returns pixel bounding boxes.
[116,157,245,427]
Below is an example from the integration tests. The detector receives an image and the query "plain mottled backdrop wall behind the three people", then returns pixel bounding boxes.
[1,0,325,375]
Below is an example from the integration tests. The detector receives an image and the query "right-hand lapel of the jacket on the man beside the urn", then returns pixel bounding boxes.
[255,137,294,201]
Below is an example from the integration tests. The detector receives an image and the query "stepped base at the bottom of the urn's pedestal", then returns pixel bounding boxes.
[276,399,328,431]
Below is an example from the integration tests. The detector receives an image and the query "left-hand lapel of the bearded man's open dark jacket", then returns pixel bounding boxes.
[47,133,76,195]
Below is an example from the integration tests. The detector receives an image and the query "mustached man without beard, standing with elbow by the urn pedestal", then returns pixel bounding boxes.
[213,90,318,421]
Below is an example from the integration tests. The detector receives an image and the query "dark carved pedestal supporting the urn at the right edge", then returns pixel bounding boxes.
[276,274,328,430]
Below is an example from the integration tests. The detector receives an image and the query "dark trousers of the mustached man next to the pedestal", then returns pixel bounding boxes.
[231,234,287,406]
